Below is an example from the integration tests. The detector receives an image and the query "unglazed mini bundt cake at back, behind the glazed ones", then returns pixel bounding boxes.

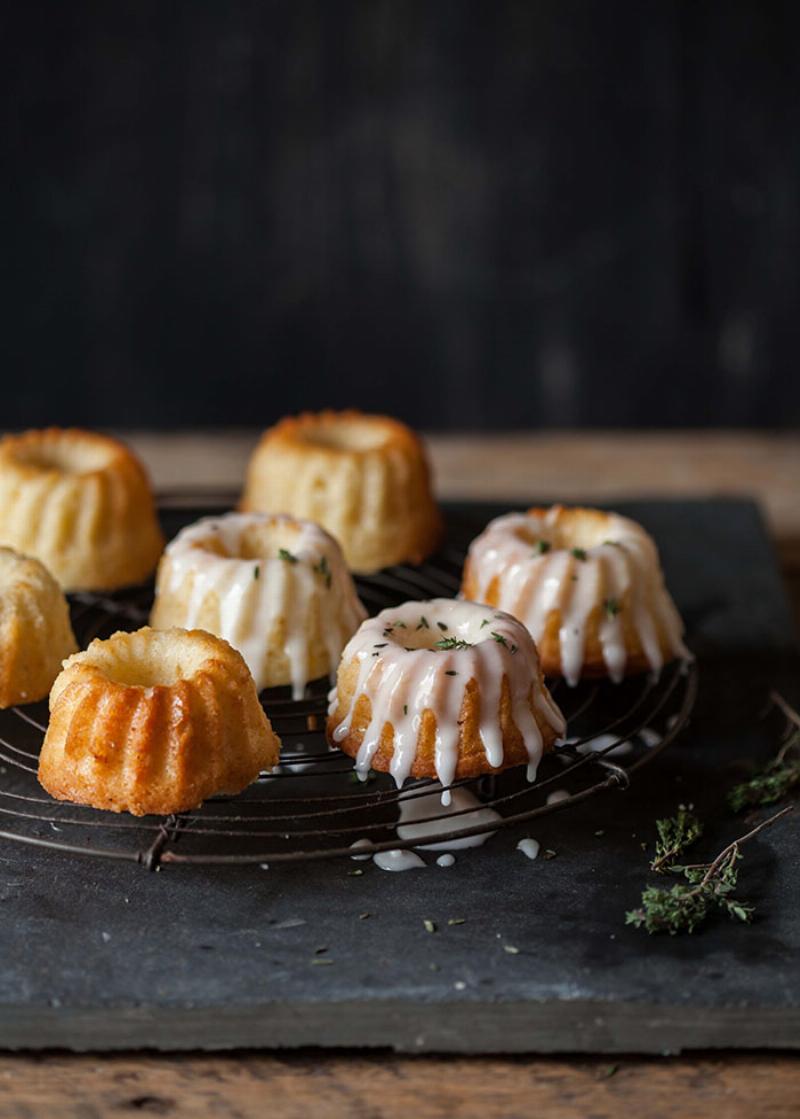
[242,412,441,572]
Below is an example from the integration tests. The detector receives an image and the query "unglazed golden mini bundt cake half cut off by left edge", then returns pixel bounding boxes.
[0,547,77,707]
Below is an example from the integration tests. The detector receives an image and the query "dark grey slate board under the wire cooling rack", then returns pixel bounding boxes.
[0,501,800,1053]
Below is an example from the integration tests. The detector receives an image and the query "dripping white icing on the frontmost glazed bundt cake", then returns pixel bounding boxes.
[330,599,565,788]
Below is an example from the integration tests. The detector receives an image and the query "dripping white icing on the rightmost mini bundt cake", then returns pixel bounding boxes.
[469,506,688,685]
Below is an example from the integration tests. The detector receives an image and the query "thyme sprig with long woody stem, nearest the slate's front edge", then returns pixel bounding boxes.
[625,805,791,935]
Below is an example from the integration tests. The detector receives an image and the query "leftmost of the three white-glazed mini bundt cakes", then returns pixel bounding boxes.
[151,513,366,699]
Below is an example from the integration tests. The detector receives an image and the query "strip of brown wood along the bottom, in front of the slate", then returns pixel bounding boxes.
[0,1054,800,1119]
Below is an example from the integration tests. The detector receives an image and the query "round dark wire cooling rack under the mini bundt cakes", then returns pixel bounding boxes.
[0,516,697,869]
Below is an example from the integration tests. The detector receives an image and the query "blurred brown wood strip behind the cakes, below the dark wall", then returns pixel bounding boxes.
[125,431,800,543]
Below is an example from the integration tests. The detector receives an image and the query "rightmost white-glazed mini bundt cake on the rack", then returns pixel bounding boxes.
[461,505,688,684]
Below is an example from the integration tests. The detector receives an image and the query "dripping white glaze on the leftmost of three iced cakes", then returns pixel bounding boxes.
[158,513,366,699]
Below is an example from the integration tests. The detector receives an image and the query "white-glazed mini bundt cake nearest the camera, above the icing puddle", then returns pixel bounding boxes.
[328,599,565,787]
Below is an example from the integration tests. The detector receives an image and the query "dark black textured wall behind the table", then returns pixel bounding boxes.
[0,0,800,429]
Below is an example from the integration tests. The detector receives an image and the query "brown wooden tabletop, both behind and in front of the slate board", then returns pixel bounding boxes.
[7,432,800,1119]
